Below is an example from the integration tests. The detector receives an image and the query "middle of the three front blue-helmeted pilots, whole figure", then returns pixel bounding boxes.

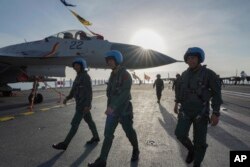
[88,50,140,167]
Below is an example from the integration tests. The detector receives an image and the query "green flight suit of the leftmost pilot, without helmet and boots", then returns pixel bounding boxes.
[64,71,99,145]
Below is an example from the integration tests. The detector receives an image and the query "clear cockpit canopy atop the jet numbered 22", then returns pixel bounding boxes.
[48,30,103,40]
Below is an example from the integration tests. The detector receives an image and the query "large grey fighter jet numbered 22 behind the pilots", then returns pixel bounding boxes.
[0,30,177,101]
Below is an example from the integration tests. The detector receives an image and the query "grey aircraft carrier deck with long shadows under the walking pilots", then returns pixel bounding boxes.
[0,85,250,167]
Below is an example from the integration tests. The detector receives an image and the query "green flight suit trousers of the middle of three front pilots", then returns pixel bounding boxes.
[100,115,138,161]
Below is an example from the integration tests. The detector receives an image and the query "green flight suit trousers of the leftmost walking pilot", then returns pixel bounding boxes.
[64,110,99,145]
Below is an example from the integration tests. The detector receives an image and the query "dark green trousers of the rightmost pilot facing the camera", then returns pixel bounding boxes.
[175,111,208,165]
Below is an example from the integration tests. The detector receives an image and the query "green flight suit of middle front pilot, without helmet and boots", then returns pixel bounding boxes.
[100,66,138,161]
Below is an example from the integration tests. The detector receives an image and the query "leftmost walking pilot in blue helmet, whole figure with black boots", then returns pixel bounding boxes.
[52,58,100,150]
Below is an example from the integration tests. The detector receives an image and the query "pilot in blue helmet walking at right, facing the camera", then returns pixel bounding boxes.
[174,47,222,167]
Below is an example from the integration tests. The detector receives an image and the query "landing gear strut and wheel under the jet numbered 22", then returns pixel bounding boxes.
[28,80,43,103]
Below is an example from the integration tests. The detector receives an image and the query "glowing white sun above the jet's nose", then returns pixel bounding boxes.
[131,29,165,52]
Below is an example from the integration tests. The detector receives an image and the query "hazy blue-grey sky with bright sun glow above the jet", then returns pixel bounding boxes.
[0,0,250,79]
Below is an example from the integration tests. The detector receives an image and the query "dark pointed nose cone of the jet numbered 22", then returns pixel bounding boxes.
[111,43,177,69]
